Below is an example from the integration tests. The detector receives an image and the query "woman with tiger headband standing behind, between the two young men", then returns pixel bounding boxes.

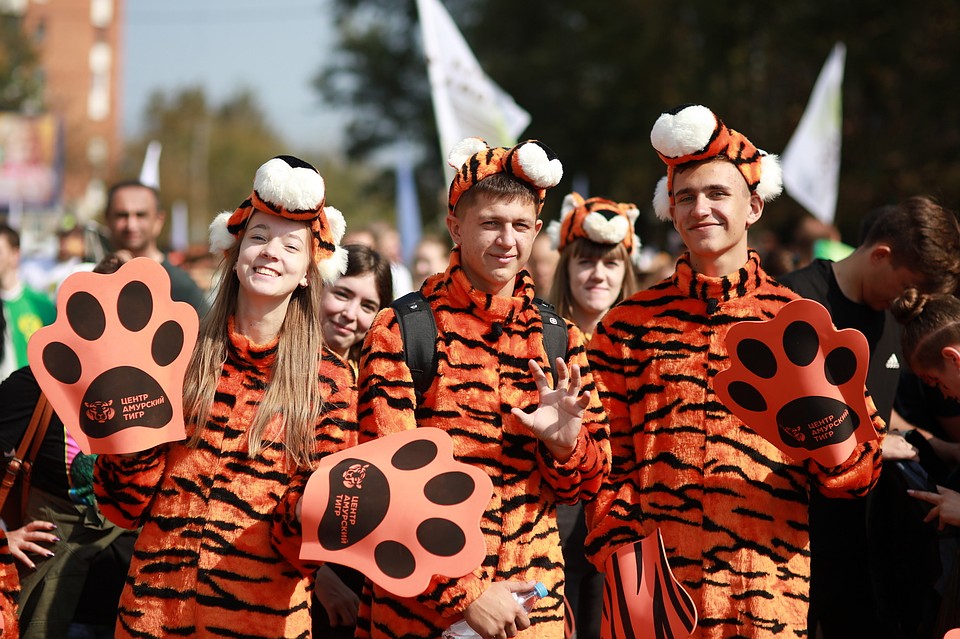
[547,193,640,639]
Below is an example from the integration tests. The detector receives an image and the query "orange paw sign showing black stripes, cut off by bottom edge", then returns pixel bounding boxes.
[600,528,697,639]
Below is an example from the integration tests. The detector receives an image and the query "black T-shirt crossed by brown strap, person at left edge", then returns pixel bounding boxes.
[0,366,70,499]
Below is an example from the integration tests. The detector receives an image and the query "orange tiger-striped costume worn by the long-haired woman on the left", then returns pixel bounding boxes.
[95,331,357,639]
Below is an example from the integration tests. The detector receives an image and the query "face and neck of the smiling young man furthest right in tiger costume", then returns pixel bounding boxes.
[670,160,763,277]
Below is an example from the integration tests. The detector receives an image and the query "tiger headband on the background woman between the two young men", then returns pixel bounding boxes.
[547,192,641,266]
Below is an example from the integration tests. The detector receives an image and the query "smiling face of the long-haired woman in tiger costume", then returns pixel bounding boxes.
[235,211,313,301]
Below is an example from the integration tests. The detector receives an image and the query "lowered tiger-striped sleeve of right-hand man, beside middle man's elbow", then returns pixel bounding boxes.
[584,323,648,572]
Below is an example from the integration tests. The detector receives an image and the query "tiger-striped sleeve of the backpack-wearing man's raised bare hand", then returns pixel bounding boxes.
[537,323,610,504]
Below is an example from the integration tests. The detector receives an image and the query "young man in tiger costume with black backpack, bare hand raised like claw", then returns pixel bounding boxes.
[356,138,610,639]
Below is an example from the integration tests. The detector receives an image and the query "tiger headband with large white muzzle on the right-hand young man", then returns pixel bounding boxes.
[650,104,783,221]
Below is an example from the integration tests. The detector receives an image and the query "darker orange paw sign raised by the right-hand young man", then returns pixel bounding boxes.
[714,299,877,466]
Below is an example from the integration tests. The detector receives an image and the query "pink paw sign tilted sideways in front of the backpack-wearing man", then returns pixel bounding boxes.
[300,428,493,597]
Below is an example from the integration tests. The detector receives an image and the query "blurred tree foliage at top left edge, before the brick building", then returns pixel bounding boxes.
[0,12,40,111]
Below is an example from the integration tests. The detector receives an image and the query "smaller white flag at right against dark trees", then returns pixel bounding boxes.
[780,42,847,224]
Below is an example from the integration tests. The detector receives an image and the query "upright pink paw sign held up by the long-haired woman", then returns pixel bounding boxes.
[27,257,199,455]
